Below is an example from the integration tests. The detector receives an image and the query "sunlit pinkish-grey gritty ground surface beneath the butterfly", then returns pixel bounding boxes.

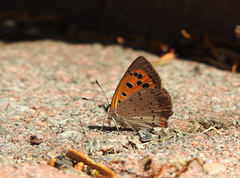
[0,40,240,178]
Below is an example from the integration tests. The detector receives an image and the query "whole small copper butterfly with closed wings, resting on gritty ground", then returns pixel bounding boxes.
[105,56,173,130]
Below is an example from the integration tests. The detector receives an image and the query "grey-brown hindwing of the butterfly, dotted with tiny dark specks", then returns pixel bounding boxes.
[115,88,173,130]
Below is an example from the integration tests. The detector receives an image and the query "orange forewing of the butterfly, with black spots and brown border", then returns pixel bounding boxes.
[109,56,162,112]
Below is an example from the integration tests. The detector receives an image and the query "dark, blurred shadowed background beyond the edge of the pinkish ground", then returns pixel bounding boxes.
[0,0,240,71]
